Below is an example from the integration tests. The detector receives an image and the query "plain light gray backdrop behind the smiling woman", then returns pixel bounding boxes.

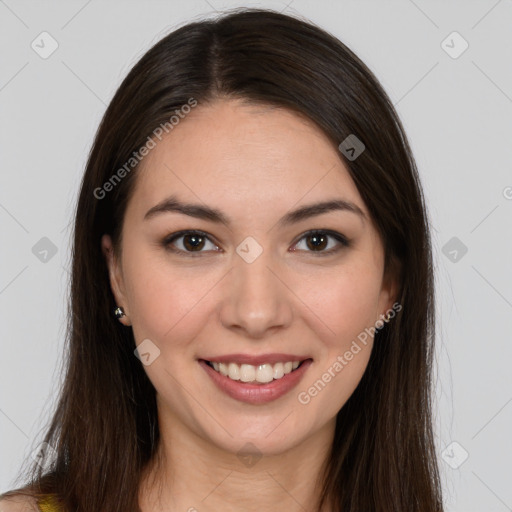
[0,0,512,512]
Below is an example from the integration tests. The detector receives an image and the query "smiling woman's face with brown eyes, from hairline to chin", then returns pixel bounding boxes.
[103,101,395,454]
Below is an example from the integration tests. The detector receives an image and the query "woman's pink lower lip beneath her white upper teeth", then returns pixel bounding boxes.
[199,359,313,404]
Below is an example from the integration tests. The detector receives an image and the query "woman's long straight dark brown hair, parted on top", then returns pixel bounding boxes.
[0,8,443,512]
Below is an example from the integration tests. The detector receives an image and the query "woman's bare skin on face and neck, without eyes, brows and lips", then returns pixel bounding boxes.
[102,100,396,512]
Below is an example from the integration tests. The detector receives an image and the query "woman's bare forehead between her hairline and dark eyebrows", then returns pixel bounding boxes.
[125,101,367,225]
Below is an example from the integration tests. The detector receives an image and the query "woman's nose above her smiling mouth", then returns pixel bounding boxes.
[220,251,293,339]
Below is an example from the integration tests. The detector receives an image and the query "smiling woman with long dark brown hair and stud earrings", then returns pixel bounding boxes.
[1,9,442,512]
